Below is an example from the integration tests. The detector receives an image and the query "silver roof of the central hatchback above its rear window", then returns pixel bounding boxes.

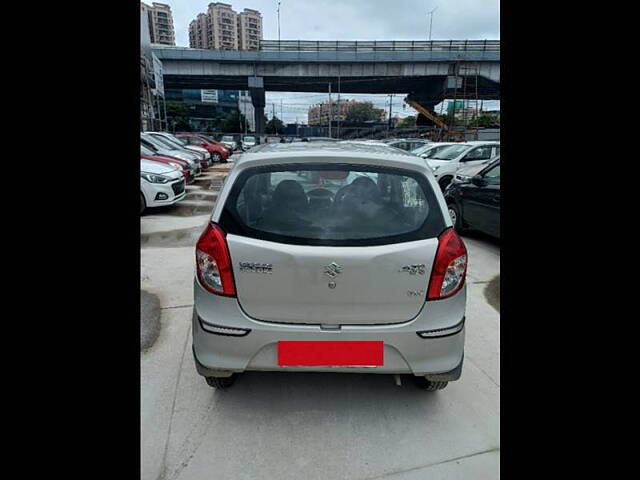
[234,142,430,173]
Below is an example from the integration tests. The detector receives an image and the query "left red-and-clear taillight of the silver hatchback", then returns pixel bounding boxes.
[196,223,236,297]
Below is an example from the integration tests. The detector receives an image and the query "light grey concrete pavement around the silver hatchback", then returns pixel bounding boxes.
[141,156,500,480]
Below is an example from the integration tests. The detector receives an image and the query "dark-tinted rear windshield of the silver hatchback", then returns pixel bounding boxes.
[220,164,445,246]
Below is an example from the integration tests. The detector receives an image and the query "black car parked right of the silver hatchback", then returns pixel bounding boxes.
[445,159,500,238]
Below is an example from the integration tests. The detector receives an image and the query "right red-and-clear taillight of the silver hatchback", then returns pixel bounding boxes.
[427,228,467,300]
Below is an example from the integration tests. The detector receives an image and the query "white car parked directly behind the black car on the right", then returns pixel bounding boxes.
[426,142,500,191]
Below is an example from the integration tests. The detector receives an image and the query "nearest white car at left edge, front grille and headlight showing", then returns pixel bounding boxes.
[140,159,186,214]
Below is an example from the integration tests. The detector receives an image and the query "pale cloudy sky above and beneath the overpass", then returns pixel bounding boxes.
[162,0,500,123]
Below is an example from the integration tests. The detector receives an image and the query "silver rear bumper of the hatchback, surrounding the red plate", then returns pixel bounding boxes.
[192,281,466,381]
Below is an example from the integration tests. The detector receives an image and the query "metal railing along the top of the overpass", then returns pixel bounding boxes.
[260,40,500,52]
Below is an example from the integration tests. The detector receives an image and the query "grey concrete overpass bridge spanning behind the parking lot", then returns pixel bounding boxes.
[152,40,500,133]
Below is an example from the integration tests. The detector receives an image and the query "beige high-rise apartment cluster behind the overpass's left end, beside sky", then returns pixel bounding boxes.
[189,2,262,50]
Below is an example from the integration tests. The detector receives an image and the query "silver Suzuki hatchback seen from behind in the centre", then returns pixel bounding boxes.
[193,142,467,390]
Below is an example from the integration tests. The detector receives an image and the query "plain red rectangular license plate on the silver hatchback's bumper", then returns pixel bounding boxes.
[278,341,384,367]
